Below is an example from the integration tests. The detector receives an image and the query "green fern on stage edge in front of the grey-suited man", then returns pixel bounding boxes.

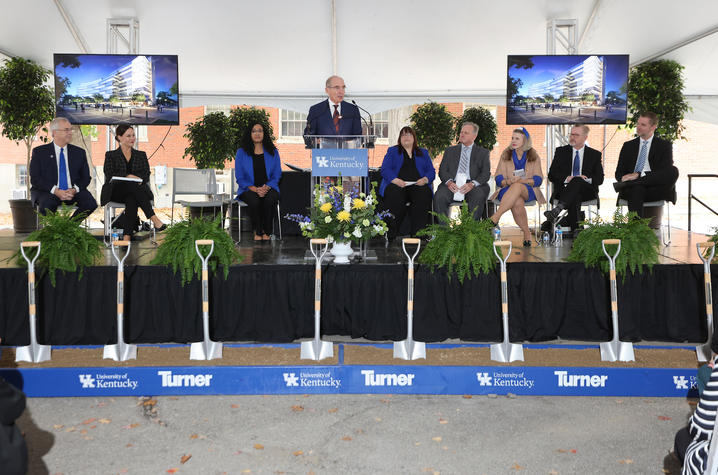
[417,202,497,284]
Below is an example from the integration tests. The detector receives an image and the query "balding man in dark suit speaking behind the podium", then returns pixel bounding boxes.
[304,76,362,135]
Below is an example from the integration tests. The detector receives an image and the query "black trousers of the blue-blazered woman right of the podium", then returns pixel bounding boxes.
[384,183,432,239]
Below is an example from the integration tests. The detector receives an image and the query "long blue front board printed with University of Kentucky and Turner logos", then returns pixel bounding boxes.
[0,365,697,398]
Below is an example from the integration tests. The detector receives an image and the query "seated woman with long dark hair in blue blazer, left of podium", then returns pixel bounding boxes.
[234,123,282,241]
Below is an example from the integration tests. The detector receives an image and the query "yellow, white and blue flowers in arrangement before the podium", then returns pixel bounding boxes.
[285,177,390,242]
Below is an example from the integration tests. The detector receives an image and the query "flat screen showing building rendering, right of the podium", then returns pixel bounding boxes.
[506,54,628,125]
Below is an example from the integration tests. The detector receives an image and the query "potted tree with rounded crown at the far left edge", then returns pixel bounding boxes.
[0,58,55,232]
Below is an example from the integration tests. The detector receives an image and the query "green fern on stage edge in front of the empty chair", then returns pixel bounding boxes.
[151,216,242,285]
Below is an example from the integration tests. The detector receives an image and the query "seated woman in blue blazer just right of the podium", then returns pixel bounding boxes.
[379,127,436,241]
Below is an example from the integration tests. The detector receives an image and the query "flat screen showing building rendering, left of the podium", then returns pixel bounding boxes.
[54,54,179,125]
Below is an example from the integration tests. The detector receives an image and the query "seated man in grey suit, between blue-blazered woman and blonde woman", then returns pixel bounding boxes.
[434,122,491,220]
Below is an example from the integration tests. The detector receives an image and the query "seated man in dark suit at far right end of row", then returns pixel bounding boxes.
[613,112,678,217]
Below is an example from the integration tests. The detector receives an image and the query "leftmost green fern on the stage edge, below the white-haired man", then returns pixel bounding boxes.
[13,204,102,287]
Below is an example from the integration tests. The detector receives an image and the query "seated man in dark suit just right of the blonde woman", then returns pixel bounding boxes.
[541,125,603,234]
